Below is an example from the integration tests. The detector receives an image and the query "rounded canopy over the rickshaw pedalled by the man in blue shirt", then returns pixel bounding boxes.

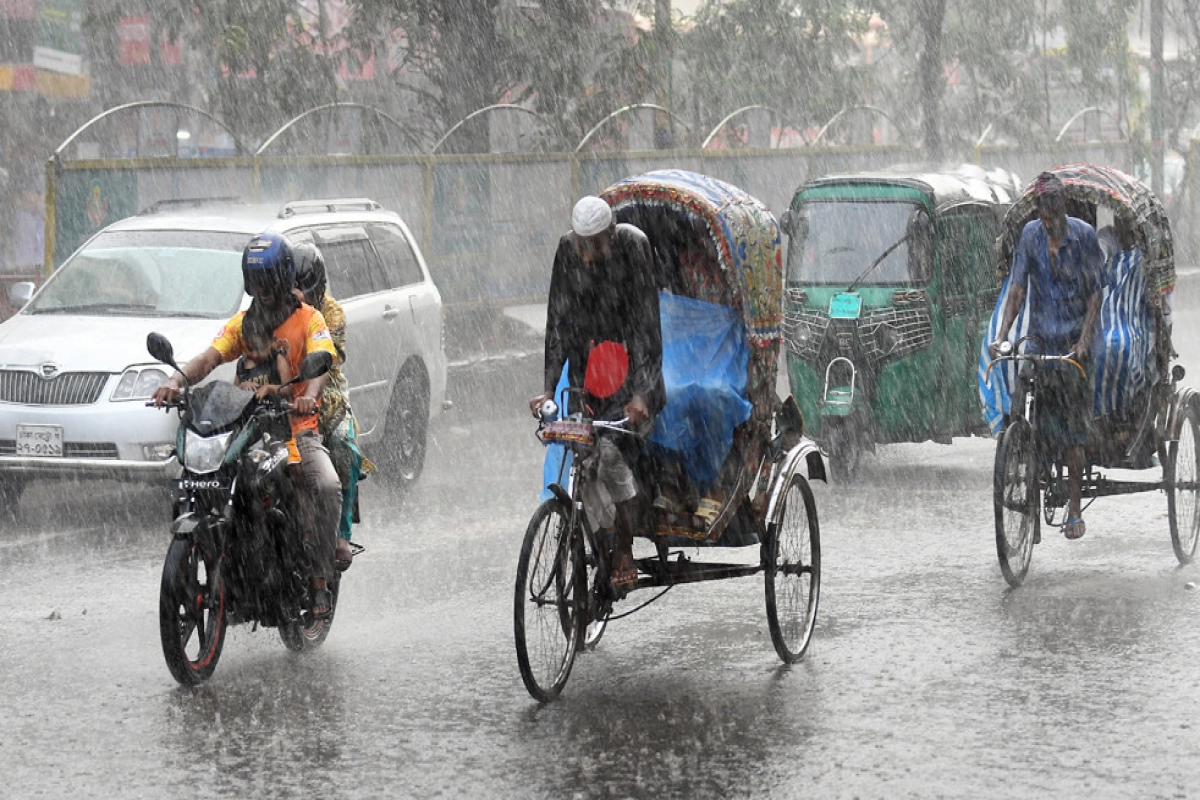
[996,164,1175,294]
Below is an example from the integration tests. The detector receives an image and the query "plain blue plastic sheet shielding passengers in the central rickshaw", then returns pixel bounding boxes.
[650,293,751,492]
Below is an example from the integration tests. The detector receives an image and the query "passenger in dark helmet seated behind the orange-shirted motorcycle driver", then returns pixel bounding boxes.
[294,242,374,571]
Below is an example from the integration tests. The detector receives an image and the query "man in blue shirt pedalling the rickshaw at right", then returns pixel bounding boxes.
[990,173,1104,539]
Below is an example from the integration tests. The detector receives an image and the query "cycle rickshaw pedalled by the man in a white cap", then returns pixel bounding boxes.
[514,170,824,702]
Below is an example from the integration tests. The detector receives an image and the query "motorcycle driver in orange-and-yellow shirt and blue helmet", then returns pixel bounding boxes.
[152,233,342,619]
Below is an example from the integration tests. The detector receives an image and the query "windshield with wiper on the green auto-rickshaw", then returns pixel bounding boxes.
[787,200,931,285]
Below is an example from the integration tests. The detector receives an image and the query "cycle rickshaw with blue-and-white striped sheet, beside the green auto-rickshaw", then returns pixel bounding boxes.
[979,164,1200,587]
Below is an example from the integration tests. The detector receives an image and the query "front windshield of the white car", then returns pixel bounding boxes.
[28,230,250,319]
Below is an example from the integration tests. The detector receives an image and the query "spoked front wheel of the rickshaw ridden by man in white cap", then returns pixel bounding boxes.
[512,499,587,703]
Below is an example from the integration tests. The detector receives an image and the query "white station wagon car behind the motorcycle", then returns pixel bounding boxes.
[0,199,446,513]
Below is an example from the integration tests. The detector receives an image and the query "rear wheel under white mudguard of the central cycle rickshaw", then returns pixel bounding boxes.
[763,475,821,663]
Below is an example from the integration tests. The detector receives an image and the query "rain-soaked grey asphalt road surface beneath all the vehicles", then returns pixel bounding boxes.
[0,284,1200,798]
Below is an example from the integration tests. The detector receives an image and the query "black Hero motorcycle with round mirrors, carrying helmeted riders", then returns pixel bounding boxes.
[146,333,340,686]
